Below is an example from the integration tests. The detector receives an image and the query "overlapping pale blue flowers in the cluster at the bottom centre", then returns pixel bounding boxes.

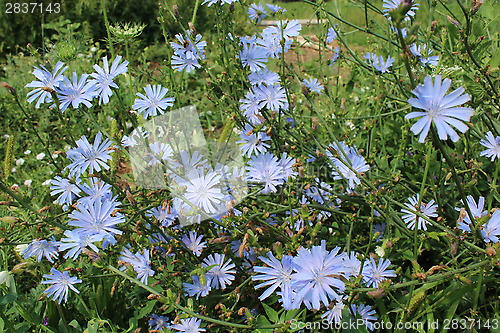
[252,241,396,328]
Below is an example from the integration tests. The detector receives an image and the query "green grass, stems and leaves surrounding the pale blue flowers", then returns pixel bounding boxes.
[0,0,500,333]
